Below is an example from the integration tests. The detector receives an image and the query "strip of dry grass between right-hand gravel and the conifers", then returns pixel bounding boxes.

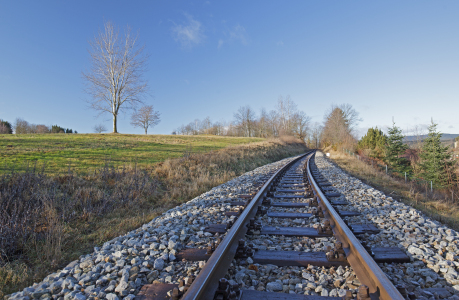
[324,149,459,230]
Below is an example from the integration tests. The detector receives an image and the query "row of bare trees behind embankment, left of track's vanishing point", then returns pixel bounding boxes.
[173,96,312,142]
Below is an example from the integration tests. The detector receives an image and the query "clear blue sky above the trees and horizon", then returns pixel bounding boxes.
[0,0,459,135]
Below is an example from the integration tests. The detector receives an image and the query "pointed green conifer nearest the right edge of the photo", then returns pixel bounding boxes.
[419,120,455,187]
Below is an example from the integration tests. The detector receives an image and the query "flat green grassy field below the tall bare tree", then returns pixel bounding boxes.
[0,134,264,175]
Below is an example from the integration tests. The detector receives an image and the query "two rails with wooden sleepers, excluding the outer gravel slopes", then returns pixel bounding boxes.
[137,152,412,300]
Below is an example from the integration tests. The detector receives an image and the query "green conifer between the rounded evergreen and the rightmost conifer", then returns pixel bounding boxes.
[385,122,411,175]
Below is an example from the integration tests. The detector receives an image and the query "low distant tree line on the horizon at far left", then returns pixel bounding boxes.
[0,118,78,134]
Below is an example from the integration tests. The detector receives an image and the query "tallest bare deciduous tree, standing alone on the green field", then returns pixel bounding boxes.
[83,22,147,133]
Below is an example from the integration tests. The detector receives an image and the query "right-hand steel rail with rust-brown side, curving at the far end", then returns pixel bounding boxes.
[307,153,405,300]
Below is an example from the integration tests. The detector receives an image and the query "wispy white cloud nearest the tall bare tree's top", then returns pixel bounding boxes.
[172,14,205,48]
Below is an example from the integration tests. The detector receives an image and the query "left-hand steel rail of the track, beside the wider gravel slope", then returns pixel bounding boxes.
[181,152,311,300]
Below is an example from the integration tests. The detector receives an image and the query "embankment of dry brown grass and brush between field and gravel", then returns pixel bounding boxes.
[0,138,307,298]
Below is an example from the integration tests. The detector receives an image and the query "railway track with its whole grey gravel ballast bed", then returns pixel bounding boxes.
[10,152,459,300]
